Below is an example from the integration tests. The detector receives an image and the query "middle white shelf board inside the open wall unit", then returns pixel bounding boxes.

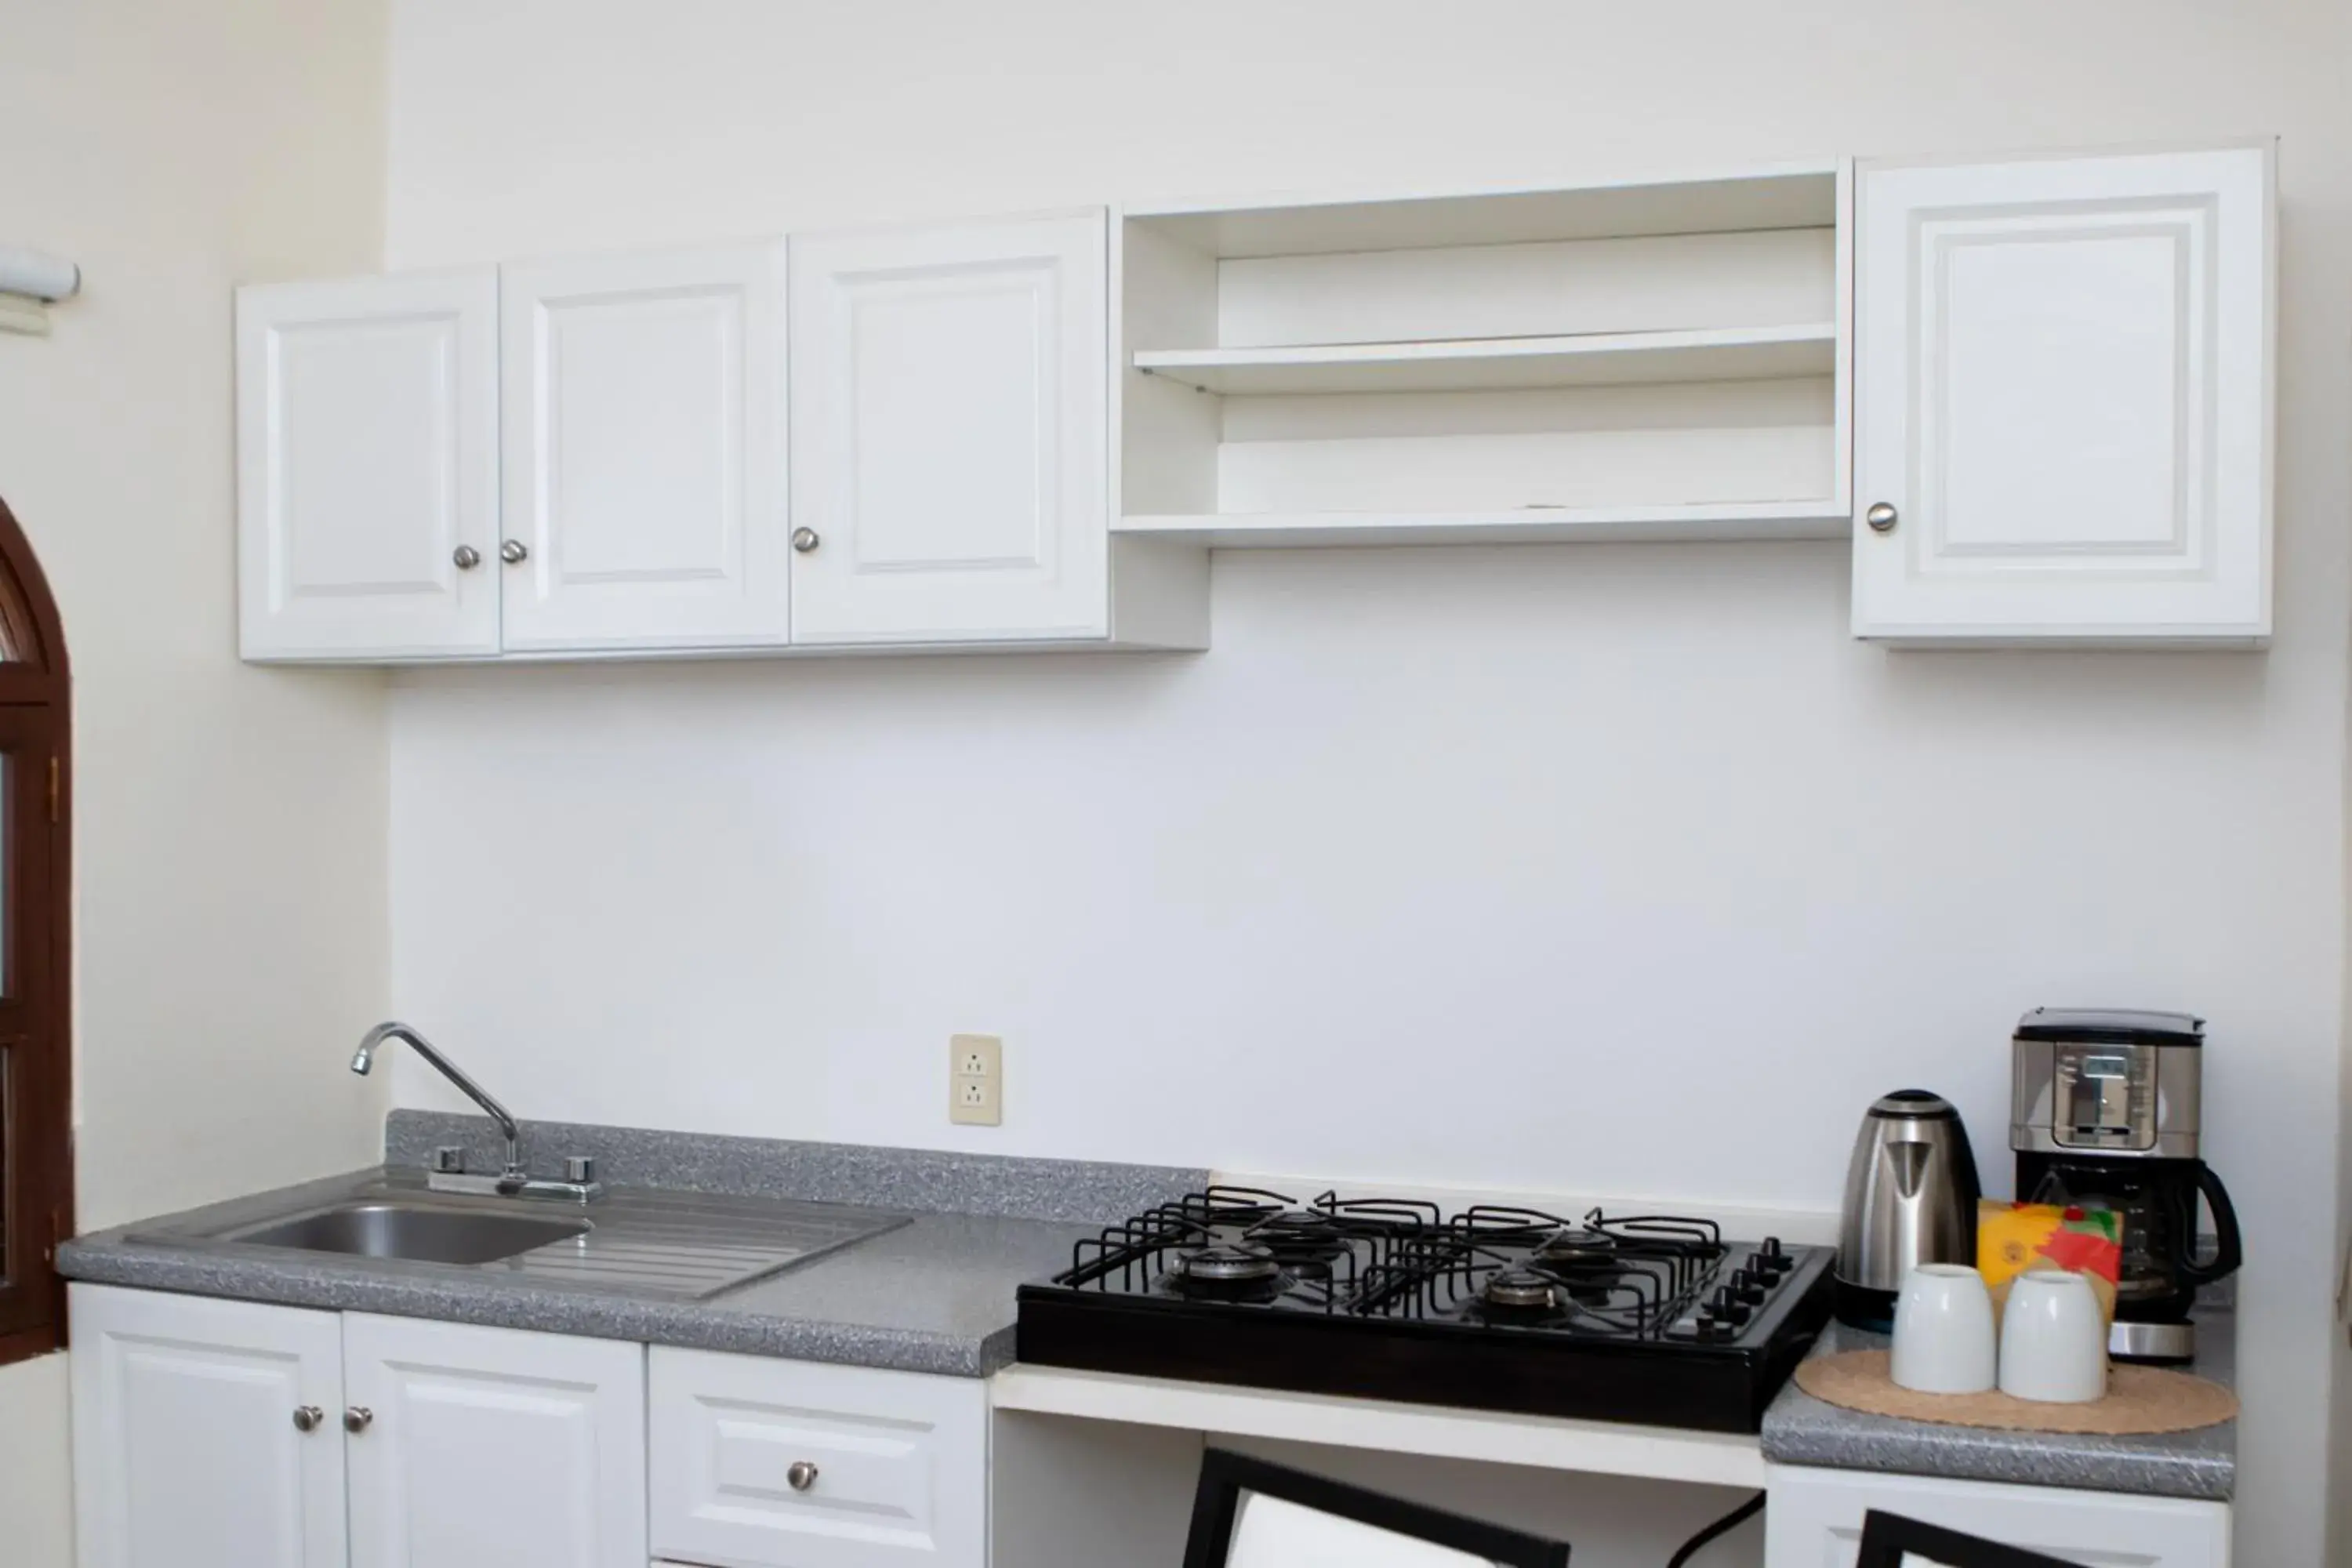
[1136,322,1837,397]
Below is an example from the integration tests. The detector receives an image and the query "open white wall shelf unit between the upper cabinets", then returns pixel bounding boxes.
[1112,165,1851,548]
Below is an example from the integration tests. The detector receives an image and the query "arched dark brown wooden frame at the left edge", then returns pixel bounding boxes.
[0,501,73,1363]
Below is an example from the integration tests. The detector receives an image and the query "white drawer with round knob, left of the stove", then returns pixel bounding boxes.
[649,1347,988,1568]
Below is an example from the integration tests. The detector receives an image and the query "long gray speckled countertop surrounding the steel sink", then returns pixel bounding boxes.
[59,1112,1207,1377]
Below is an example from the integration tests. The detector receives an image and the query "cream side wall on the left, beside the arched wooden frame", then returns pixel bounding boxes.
[0,0,388,1568]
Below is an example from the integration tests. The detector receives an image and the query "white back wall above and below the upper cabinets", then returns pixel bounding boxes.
[388,0,2352,1568]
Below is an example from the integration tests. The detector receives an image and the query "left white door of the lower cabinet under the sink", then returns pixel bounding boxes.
[71,1286,346,1568]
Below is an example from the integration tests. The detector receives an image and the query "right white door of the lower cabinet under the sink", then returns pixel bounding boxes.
[336,1312,647,1568]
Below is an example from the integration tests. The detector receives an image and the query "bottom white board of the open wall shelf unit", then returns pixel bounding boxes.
[1110,501,1851,550]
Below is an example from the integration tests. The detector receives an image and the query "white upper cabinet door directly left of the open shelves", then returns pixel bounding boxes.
[790,212,1110,644]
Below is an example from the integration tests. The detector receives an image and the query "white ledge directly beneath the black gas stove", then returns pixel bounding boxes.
[988,1366,1764,1486]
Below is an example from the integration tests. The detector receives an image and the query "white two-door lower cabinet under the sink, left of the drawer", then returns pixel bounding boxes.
[71,1286,647,1568]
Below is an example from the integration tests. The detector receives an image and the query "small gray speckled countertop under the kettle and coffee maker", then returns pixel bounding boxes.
[1764,1314,2237,1502]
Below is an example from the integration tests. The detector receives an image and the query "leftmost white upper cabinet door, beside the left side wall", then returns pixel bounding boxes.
[238,268,499,661]
